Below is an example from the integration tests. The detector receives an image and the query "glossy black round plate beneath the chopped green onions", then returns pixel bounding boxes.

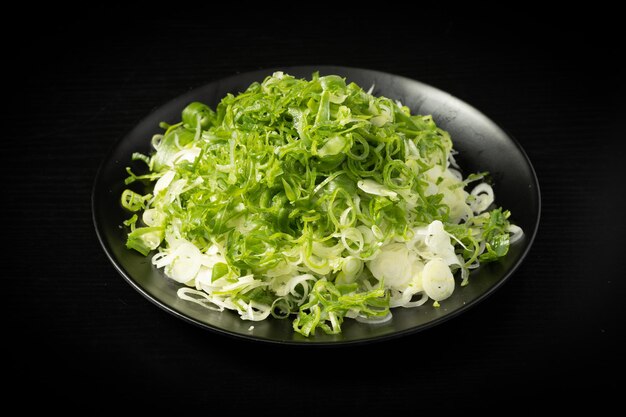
[92,66,541,345]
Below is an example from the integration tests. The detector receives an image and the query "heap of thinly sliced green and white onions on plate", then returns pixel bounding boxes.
[121,72,522,336]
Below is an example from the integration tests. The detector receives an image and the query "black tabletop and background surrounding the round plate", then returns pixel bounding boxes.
[7,15,626,415]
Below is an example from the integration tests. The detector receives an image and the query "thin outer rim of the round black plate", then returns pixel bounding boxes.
[90,65,542,347]
